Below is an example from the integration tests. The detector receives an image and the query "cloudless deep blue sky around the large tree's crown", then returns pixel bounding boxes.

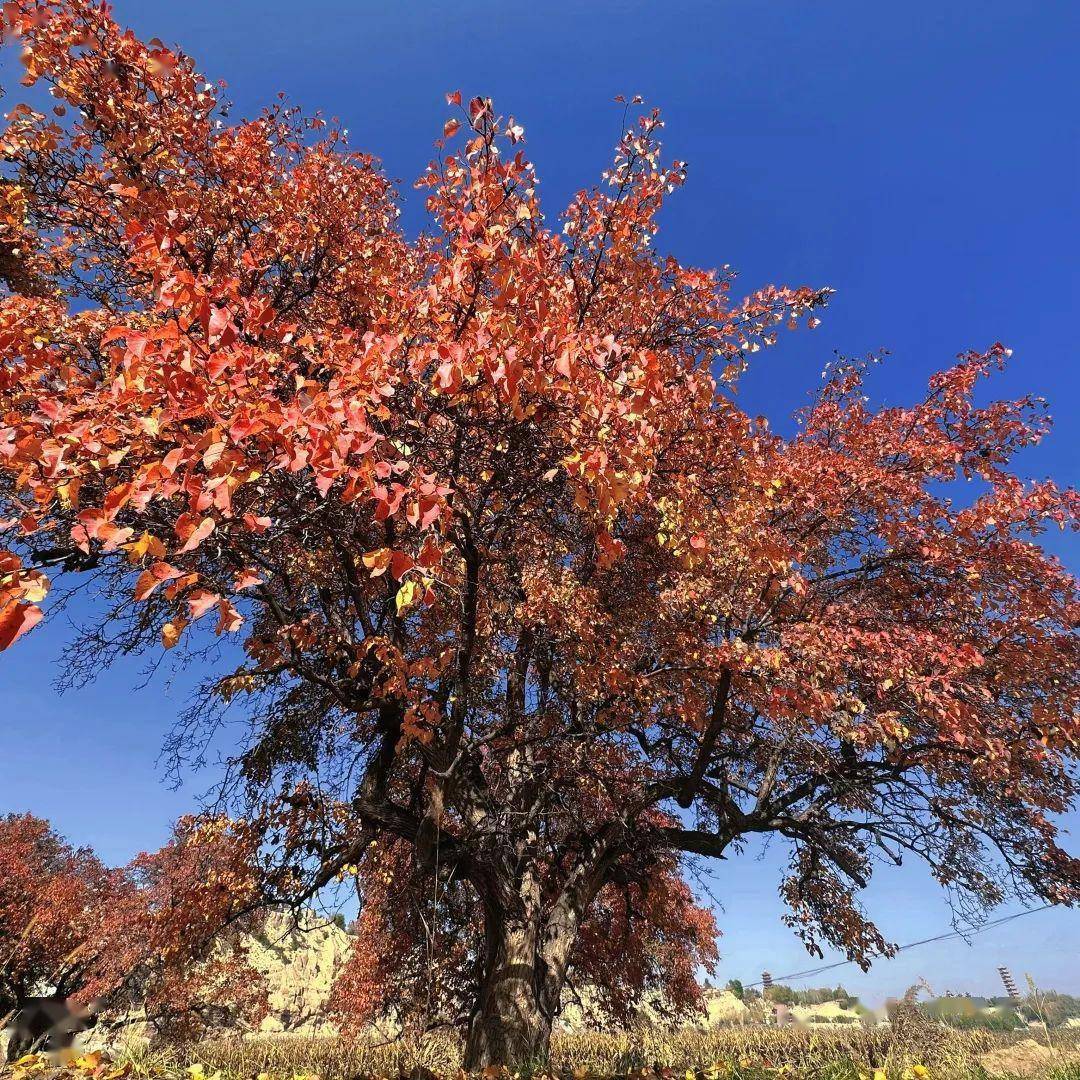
[0,0,1080,1001]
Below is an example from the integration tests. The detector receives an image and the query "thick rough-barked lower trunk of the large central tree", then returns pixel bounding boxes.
[464,917,563,1071]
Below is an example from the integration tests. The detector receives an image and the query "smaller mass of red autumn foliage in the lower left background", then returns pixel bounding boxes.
[0,814,267,1055]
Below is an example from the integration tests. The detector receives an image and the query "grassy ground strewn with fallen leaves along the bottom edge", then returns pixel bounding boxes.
[8,1010,1080,1080]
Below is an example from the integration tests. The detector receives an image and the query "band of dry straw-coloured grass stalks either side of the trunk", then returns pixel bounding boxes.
[107,1021,1080,1080]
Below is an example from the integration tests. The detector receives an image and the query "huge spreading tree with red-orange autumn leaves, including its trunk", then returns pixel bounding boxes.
[0,0,1080,1066]
